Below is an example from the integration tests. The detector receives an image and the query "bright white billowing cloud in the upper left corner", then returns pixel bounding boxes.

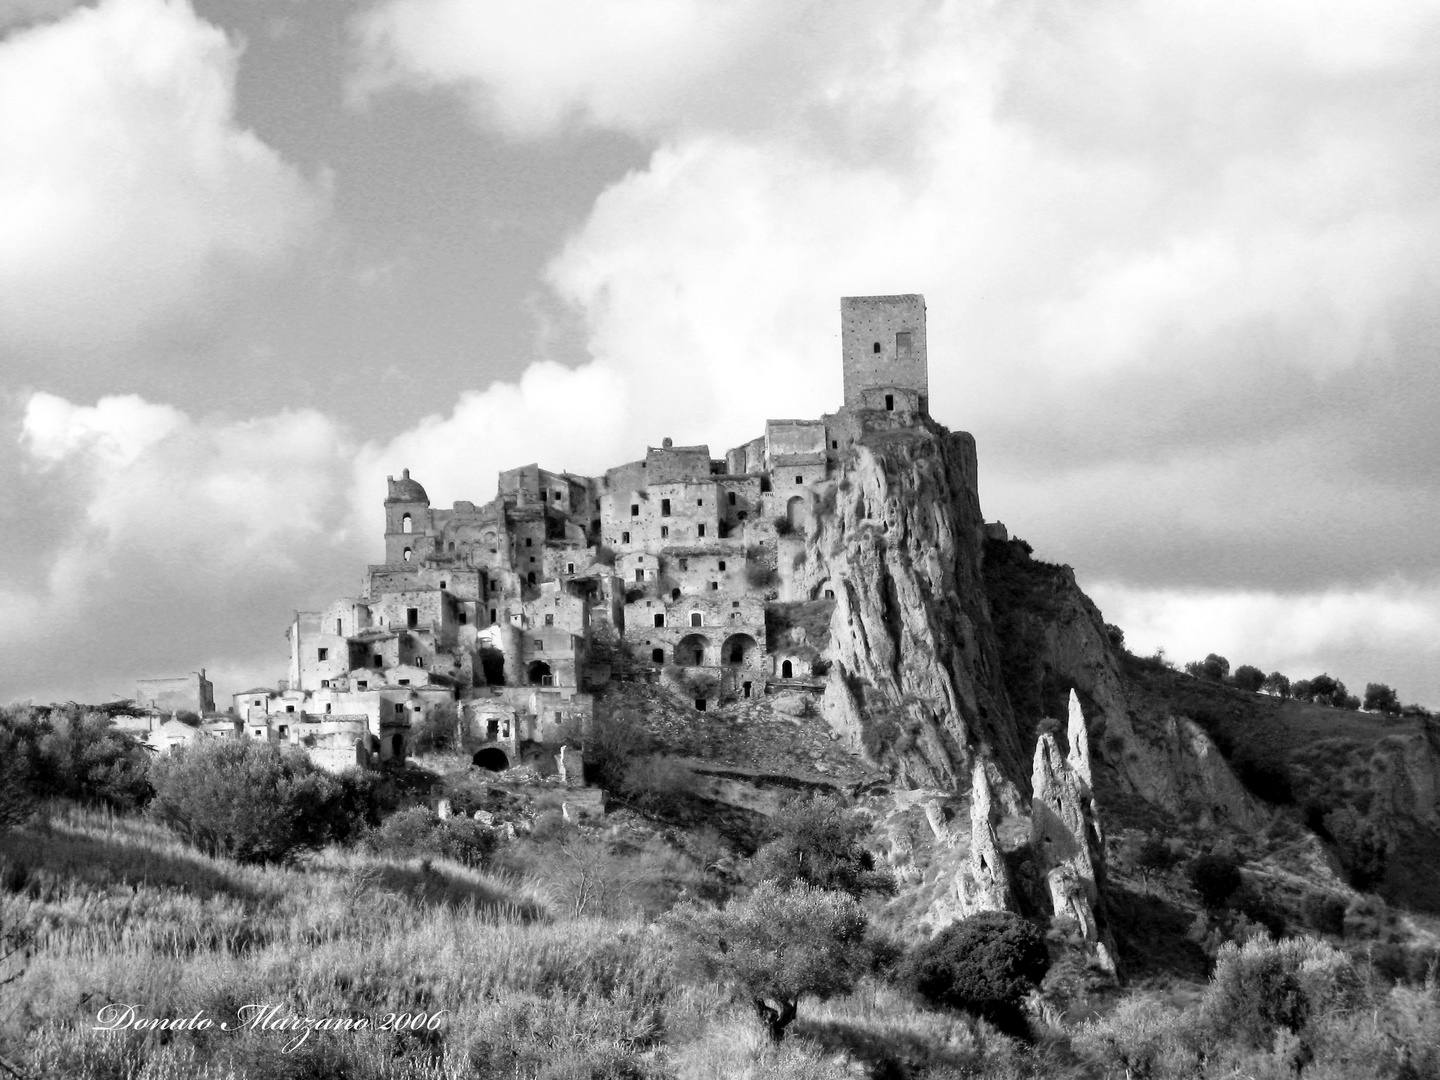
[0,0,327,346]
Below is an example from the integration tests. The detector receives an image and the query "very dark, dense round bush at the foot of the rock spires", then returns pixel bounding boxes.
[903,912,1050,1037]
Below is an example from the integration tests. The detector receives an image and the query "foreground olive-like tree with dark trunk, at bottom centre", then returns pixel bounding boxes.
[662,881,870,1043]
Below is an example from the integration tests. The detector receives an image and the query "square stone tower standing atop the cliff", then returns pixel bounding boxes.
[840,292,930,413]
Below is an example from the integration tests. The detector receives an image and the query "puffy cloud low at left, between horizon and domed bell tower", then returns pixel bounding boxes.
[0,393,362,700]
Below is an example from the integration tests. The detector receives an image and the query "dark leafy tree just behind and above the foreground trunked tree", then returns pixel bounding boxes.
[749,795,896,897]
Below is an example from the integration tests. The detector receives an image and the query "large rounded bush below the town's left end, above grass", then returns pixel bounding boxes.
[151,739,344,863]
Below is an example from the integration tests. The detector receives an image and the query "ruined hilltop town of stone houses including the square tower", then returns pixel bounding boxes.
[250,295,929,768]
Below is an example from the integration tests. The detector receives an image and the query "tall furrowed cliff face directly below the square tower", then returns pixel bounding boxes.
[791,423,1025,806]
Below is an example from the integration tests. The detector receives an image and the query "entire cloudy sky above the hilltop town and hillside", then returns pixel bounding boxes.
[0,0,1440,707]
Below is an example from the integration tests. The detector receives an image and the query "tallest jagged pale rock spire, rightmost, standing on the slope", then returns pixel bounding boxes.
[1030,691,1115,973]
